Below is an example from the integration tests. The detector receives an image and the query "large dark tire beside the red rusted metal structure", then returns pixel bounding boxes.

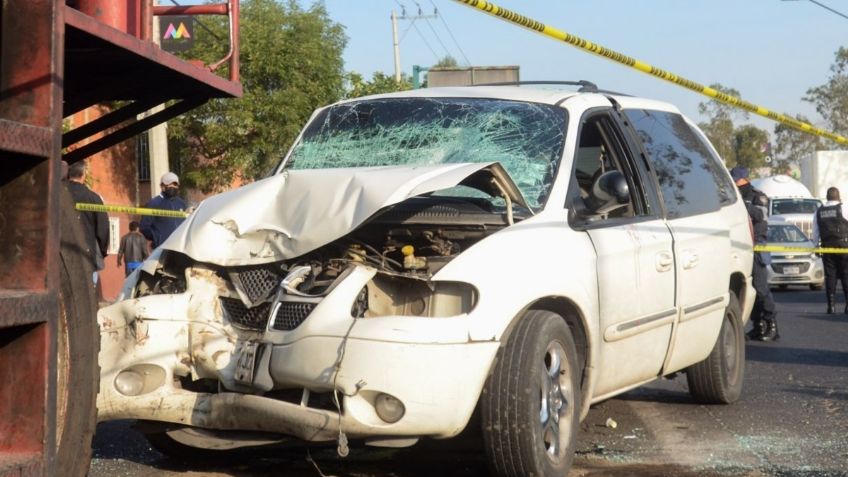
[56,187,100,477]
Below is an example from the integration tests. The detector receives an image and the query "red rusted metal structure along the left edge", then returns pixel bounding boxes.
[0,0,242,476]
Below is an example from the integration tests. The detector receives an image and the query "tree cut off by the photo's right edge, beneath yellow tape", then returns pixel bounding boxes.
[804,47,848,134]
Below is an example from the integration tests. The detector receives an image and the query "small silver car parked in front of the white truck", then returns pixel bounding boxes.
[768,216,824,290]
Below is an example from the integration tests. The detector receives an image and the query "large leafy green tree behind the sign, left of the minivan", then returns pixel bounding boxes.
[169,0,347,192]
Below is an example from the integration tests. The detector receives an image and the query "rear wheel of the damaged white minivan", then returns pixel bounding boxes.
[686,293,745,404]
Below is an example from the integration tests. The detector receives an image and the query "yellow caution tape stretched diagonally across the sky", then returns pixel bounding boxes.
[454,0,848,144]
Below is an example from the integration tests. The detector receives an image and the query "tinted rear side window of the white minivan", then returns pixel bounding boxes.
[624,109,736,218]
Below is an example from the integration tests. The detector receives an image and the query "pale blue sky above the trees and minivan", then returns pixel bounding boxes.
[314,0,848,140]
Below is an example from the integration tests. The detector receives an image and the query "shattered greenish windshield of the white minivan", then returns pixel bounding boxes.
[286,98,566,209]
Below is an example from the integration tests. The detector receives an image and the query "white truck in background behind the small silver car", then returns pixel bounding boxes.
[751,174,820,237]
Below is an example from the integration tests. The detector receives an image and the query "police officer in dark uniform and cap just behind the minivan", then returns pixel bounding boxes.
[730,166,780,341]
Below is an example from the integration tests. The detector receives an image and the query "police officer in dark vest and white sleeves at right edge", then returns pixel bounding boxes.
[812,187,848,314]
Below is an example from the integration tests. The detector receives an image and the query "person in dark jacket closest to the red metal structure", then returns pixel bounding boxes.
[68,161,109,285]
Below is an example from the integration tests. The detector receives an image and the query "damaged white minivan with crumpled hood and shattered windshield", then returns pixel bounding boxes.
[98,86,754,476]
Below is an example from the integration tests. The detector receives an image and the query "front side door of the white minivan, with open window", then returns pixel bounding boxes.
[569,109,677,397]
